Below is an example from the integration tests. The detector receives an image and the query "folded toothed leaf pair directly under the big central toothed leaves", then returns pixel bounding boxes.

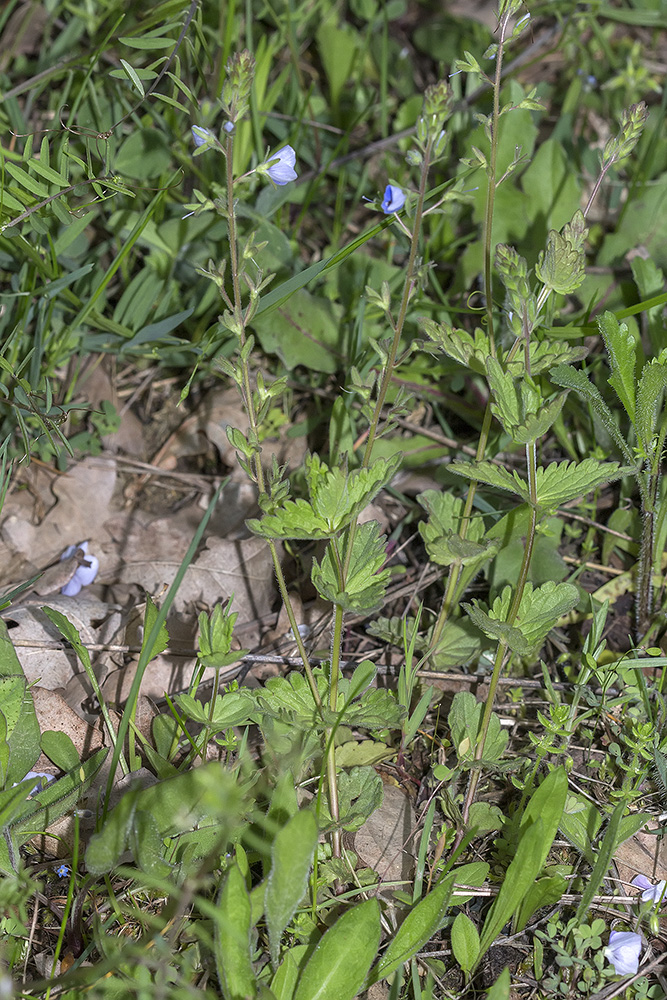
[311,521,391,614]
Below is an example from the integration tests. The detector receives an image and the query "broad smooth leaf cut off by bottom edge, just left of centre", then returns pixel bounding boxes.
[294,899,380,1000]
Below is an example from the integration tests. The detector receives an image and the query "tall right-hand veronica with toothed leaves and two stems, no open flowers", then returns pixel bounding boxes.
[424,0,658,821]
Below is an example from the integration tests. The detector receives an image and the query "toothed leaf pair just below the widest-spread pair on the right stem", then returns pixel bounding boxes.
[463,580,579,656]
